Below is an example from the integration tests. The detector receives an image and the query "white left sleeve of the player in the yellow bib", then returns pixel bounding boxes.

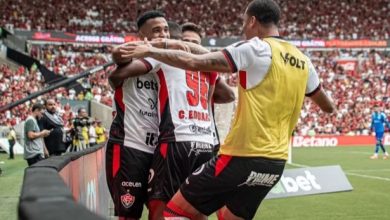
[222,38,269,72]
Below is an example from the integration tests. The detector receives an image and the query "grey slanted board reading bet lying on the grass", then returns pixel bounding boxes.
[266,166,353,199]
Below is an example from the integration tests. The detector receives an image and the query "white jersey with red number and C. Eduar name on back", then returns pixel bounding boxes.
[145,58,217,144]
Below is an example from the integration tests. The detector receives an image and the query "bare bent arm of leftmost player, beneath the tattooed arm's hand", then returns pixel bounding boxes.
[108,60,151,88]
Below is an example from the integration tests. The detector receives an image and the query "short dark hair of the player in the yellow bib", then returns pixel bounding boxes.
[247,0,281,25]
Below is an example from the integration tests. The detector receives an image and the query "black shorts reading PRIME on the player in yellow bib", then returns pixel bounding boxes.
[180,155,286,219]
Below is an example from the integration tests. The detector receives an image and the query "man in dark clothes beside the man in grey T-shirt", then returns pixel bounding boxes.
[38,99,67,156]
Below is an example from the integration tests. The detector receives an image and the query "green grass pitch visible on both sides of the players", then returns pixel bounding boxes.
[0,147,390,220]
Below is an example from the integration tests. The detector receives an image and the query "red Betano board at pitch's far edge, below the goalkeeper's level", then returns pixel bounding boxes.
[291,135,390,147]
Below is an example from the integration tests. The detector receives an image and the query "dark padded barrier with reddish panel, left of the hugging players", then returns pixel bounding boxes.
[18,145,109,220]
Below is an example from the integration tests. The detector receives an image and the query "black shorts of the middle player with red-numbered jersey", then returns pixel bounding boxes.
[148,142,214,202]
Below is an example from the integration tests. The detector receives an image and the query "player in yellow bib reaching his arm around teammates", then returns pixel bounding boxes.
[126,0,335,219]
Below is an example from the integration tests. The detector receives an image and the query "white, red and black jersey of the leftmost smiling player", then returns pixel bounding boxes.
[110,73,158,153]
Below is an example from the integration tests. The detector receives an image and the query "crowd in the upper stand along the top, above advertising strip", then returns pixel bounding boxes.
[0,0,390,39]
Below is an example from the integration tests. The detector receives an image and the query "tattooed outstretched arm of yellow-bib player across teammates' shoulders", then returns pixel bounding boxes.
[123,44,233,73]
